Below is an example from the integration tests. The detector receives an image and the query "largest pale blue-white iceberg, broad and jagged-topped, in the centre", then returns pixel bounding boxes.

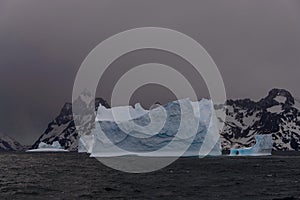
[83,99,222,157]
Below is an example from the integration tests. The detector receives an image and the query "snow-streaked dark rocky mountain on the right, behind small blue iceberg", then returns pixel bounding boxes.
[221,89,300,151]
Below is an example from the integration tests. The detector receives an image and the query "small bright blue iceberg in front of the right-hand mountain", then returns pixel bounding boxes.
[230,134,273,156]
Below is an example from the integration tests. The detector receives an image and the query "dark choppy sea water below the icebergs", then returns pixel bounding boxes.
[0,153,300,200]
